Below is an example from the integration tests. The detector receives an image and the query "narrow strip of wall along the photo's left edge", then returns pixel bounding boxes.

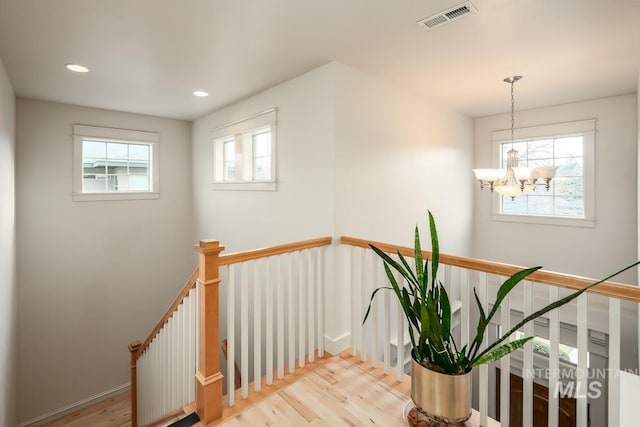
[0,59,18,426]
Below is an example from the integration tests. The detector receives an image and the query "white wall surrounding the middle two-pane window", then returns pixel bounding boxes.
[193,61,334,253]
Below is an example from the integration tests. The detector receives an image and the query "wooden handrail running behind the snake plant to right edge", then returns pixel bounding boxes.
[340,236,640,303]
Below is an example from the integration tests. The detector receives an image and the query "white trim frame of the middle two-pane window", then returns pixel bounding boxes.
[211,107,278,191]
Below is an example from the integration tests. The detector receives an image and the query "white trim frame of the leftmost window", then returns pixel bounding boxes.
[72,125,160,202]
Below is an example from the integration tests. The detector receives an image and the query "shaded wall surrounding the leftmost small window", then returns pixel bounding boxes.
[16,99,196,422]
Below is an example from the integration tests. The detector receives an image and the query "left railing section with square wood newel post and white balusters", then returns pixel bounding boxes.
[129,237,331,427]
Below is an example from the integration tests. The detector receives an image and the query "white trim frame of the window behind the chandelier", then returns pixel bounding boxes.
[491,119,596,227]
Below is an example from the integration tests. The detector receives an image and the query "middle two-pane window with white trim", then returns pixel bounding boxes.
[213,108,276,191]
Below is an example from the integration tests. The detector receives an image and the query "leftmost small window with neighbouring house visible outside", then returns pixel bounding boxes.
[73,125,158,201]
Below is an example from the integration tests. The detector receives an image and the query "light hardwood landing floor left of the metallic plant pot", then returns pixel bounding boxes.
[210,356,411,427]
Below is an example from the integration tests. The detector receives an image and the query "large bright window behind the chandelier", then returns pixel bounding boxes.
[493,120,595,227]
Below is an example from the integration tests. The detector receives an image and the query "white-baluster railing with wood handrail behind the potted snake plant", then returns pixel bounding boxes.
[341,237,640,427]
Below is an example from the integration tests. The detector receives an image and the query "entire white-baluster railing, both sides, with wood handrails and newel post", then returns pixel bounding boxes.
[129,237,640,427]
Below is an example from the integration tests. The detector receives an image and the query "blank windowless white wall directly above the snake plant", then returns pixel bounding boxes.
[327,64,473,346]
